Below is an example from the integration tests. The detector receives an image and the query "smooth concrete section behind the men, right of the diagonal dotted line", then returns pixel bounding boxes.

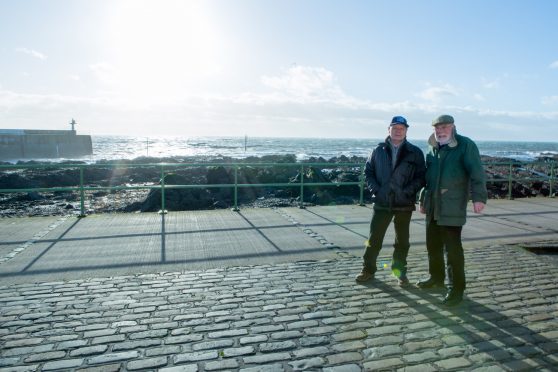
[283,198,558,253]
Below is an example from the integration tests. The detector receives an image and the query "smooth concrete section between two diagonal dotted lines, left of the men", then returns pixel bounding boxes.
[0,209,335,283]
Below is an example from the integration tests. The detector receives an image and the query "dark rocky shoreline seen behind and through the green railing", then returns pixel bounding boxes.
[0,155,558,217]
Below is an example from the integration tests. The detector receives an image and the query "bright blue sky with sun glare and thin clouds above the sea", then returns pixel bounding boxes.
[0,0,558,142]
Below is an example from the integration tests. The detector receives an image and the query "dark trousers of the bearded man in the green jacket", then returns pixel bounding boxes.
[426,221,465,293]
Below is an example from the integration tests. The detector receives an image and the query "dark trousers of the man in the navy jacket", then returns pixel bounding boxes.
[363,209,413,276]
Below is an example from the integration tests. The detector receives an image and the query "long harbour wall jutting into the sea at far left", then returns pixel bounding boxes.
[0,129,93,160]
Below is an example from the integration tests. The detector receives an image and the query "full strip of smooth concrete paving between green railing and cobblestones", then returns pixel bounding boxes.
[0,198,558,283]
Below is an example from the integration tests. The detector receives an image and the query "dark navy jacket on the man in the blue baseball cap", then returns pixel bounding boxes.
[364,137,426,211]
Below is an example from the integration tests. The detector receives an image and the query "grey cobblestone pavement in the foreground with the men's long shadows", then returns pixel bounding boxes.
[0,240,558,372]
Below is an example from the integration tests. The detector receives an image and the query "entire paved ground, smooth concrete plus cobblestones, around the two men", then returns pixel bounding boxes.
[0,198,558,371]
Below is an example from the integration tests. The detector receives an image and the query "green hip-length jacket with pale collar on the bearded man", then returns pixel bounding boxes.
[420,129,488,226]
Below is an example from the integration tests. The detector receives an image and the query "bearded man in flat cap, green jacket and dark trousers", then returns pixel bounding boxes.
[417,115,487,306]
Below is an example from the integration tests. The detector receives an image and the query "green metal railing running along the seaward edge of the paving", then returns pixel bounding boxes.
[0,161,557,217]
